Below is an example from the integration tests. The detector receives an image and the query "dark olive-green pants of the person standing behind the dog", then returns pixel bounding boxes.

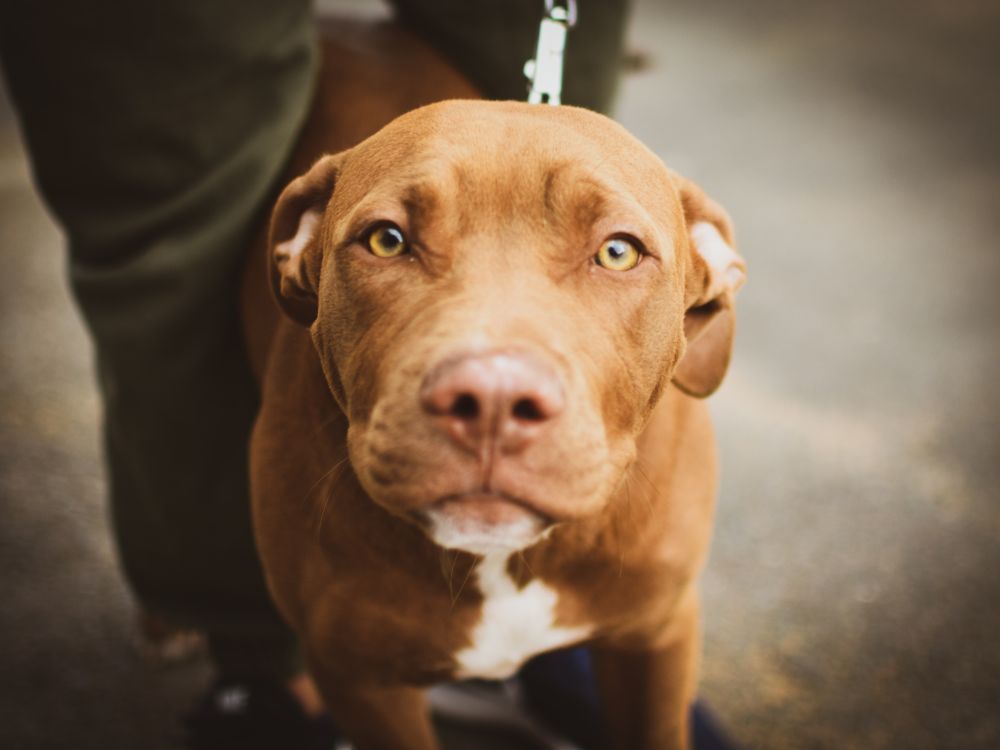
[0,0,628,674]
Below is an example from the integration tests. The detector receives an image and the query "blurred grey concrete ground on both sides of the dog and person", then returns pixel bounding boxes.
[0,0,1000,750]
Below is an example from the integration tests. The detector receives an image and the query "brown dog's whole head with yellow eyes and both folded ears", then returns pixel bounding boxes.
[271,102,743,553]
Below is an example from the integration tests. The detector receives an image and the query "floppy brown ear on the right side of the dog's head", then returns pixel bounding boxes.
[671,172,746,398]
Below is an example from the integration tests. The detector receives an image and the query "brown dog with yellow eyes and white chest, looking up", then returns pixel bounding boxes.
[247,22,744,750]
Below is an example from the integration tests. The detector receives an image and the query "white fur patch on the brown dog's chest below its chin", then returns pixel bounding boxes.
[455,552,592,679]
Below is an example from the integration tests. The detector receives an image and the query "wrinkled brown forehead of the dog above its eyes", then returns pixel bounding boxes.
[328,102,676,231]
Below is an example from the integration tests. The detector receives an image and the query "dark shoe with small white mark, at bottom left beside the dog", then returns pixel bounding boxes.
[184,678,340,750]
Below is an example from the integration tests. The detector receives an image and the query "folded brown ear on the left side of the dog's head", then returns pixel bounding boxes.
[268,154,342,327]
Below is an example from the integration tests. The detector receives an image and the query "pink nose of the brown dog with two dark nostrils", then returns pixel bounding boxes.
[420,352,565,453]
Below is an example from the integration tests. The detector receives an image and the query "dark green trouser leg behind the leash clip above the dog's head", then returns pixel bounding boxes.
[391,0,632,113]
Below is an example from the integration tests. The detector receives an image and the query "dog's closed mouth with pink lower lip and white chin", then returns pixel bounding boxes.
[411,491,555,555]
